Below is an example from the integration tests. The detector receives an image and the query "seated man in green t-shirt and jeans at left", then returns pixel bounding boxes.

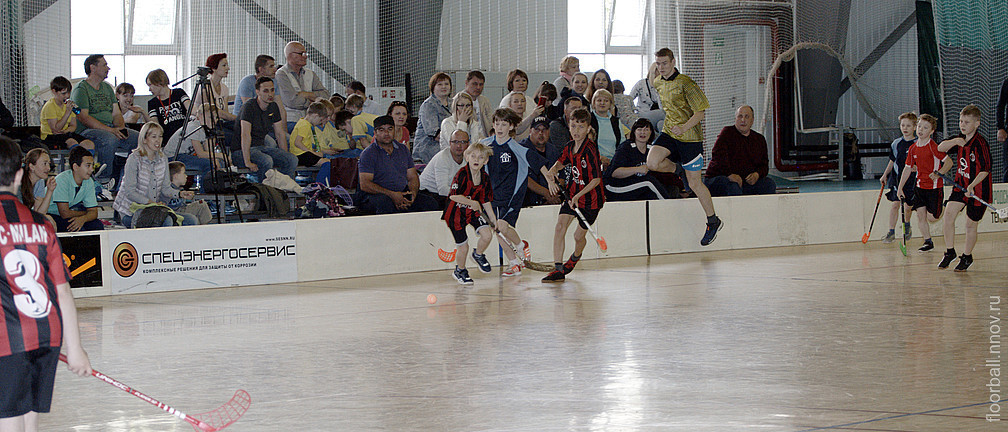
[70,54,137,182]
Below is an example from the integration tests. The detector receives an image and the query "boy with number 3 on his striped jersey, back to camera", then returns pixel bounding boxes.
[0,138,91,432]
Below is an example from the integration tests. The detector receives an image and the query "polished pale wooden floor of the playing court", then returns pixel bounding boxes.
[41,234,1008,432]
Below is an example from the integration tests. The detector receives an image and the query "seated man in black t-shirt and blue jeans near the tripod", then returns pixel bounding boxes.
[231,77,297,181]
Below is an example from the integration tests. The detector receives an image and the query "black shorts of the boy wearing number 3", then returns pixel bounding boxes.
[0,346,59,418]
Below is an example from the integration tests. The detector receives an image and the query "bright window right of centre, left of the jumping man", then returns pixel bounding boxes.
[568,0,650,91]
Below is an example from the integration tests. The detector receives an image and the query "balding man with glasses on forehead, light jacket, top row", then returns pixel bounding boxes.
[276,41,330,130]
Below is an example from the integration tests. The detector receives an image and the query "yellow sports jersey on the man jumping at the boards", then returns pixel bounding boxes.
[653,70,711,142]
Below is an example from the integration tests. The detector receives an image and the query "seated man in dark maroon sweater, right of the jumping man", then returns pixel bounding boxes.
[704,105,777,196]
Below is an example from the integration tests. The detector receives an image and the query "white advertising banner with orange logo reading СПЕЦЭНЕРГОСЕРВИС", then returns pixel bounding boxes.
[105,222,297,294]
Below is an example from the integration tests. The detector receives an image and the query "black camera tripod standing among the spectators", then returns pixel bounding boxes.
[171,66,245,224]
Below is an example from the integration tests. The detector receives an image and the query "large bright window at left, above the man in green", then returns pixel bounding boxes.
[71,0,179,95]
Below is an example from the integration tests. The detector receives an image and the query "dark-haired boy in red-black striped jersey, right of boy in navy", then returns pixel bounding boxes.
[542,108,606,282]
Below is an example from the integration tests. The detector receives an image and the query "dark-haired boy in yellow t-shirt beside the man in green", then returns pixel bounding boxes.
[40,77,95,151]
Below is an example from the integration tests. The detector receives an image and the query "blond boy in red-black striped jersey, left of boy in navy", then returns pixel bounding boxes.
[442,142,521,285]
